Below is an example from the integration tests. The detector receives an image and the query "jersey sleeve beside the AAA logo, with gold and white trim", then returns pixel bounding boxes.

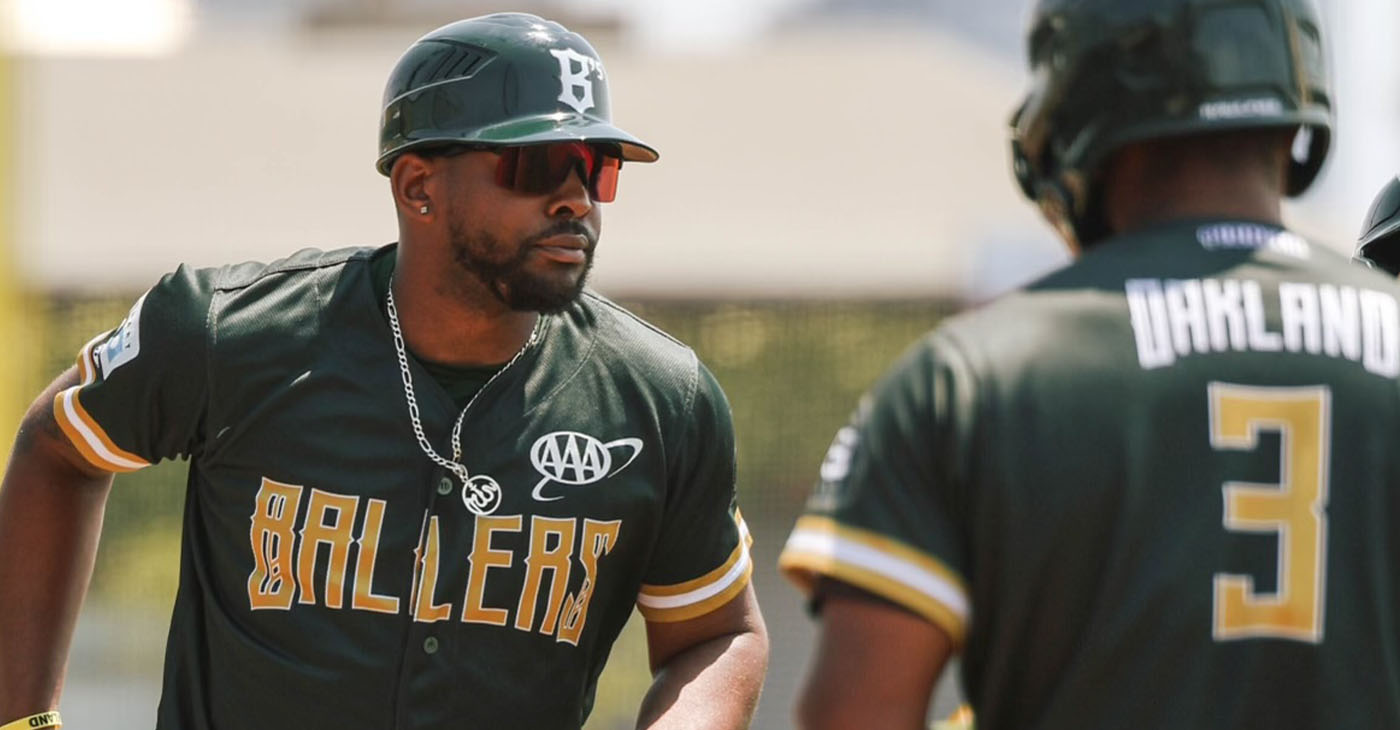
[637,364,753,622]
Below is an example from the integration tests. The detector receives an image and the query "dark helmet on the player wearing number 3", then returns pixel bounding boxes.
[1011,0,1333,245]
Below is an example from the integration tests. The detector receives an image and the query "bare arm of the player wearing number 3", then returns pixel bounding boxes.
[797,591,952,730]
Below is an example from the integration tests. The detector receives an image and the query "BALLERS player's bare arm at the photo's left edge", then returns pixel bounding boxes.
[0,369,112,724]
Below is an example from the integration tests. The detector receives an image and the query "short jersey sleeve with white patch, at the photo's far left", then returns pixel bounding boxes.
[53,266,213,472]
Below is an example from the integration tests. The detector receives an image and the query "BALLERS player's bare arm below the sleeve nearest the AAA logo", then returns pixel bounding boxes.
[637,586,769,730]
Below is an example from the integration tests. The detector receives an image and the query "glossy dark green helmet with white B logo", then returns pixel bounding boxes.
[375,13,658,175]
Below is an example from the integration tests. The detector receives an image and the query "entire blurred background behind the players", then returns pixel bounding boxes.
[0,0,1400,730]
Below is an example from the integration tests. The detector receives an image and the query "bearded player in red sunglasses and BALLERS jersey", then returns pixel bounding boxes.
[0,14,767,730]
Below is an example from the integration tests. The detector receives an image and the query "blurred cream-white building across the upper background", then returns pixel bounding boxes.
[10,0,1400,298]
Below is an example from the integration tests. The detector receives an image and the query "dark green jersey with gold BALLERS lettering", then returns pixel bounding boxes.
[55,249,750,730]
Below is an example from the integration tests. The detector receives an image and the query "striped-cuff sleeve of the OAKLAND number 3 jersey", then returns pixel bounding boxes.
[778,336,970,646]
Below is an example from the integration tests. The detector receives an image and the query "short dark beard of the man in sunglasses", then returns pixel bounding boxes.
[448,220,598,314]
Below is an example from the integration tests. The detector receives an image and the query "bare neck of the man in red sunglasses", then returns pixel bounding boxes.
[392,253,539,367]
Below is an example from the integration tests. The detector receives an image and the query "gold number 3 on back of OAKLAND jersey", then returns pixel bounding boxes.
[1208,383,1331,643]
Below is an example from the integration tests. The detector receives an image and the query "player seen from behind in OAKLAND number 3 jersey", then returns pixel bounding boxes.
[780,0,1400,730]
